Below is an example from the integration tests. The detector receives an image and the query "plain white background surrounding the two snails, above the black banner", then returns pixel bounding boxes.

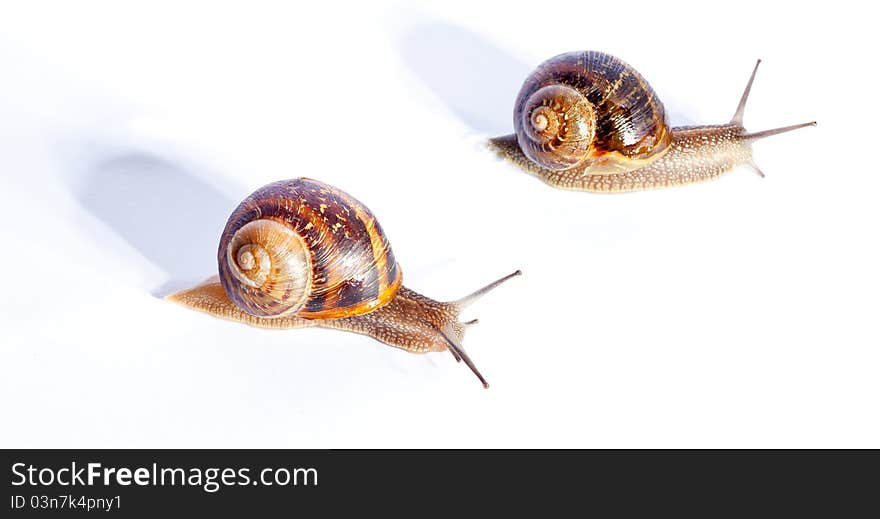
[0,0,880,447]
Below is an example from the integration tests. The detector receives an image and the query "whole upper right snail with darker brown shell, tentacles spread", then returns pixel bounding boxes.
[489,51,816,192]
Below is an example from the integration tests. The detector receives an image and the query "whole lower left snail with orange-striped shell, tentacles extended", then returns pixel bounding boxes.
[167,178,520,388]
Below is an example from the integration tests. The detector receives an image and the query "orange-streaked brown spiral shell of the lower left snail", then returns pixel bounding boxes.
[217,178,401,319]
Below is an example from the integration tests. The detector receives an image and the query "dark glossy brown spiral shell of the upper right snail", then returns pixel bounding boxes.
[514,51,672,174]
